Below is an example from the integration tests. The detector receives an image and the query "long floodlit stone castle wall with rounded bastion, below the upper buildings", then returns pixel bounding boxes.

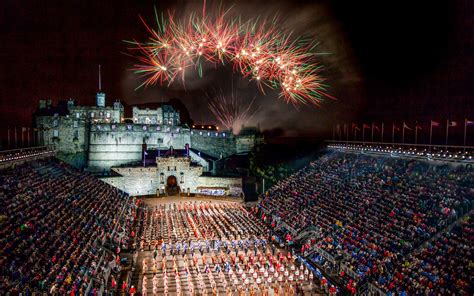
[36,113,258,172]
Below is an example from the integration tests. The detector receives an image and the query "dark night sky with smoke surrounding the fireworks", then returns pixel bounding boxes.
[0,0,474,139]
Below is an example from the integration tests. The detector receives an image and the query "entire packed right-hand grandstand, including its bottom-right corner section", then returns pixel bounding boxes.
[260,151,474,295]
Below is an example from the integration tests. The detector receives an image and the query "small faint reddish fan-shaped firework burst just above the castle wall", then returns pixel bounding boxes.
[208,90,259,131]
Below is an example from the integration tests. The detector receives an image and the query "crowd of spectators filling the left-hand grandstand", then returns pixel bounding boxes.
[0,158,134,295]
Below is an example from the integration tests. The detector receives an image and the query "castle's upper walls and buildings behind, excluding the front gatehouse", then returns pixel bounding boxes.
[36,100,263,172]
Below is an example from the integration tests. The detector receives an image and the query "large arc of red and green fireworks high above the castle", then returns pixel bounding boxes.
[129,4,330,106]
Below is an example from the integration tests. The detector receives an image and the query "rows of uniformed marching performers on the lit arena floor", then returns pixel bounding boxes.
[133,202,315,296]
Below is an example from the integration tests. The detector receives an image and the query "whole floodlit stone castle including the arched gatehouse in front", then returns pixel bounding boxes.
[35,91,263,195]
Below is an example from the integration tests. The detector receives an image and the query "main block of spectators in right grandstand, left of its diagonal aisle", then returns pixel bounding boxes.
[260,152,474,290]
